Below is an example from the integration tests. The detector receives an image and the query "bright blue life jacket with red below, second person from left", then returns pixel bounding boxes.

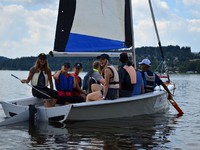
[55,74,74,96]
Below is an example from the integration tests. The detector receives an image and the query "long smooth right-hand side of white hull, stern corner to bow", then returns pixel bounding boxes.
[67,92,169,120]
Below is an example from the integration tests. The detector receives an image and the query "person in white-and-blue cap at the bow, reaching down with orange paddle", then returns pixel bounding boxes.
[139,59,172,99]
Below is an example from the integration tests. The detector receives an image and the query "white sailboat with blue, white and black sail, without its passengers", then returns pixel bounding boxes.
[0,0,181,125]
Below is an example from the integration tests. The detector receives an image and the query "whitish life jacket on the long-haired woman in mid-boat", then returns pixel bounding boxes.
[107,65,119,89]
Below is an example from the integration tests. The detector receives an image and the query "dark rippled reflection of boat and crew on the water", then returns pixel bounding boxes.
[1,114,179,150]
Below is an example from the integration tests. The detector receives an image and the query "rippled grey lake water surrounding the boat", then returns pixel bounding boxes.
[0,71,200,150]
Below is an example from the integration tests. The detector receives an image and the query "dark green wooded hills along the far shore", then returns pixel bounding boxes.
[0,45,200,73]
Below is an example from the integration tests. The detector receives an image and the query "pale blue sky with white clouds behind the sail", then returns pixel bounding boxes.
[0,0,200,58]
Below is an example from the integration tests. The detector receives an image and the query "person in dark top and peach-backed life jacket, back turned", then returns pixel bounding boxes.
[118,52,136,97]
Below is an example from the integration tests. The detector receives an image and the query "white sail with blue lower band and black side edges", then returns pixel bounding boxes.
[54,0,132,55]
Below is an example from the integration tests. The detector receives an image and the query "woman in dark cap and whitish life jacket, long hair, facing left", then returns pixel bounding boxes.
[97,54,119,100]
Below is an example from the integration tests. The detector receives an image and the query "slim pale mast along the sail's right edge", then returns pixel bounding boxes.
[129,0,136,69]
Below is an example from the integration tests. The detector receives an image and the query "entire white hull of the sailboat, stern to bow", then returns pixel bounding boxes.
[1,86,173,122]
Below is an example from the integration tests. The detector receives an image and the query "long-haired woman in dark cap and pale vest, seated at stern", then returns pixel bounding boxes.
[21,53,58,99]
